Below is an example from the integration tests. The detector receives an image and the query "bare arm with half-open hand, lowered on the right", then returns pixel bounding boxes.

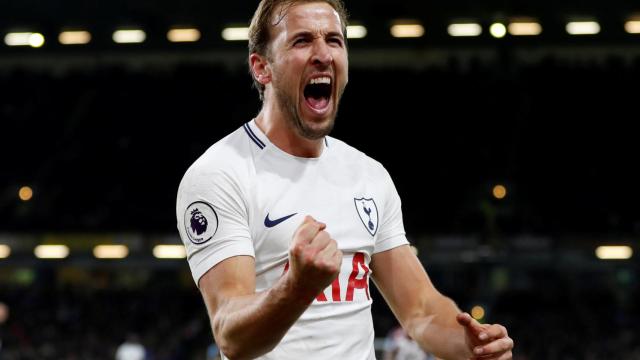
[371,246,513,360]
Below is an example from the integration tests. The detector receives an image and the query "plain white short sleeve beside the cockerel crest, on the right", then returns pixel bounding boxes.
[373,168,409,254]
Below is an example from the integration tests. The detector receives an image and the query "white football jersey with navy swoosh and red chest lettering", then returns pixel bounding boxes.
[176,121,408,360]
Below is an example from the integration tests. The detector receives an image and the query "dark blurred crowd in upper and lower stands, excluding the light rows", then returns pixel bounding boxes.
[0,57,640,360]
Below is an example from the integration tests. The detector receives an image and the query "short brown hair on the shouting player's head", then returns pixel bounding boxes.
[249,0,348,100]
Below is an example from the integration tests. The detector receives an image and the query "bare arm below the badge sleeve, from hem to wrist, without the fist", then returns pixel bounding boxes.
[200,256,313,359]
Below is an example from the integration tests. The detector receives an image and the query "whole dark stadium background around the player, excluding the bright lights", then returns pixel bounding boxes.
[0,0,640,359]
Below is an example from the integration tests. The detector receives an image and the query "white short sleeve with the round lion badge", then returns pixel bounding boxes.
[176,169,255,285]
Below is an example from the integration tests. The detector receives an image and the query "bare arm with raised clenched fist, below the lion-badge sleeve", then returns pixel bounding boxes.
[199,217,342,360]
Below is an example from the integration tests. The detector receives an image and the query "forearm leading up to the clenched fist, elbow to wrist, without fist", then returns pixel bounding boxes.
[211,276,315,360]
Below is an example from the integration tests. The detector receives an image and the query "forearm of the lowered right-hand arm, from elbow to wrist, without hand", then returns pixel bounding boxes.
[404,296,472,360]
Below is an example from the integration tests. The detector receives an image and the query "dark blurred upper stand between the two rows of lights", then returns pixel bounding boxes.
[5,57,640,235]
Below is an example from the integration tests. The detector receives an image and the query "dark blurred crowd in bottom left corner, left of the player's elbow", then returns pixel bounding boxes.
[0,282,212,360]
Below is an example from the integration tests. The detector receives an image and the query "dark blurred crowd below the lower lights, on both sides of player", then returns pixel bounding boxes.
[0,266,640,360]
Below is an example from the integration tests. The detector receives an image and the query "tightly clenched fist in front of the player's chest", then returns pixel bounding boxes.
[288,215,342,299]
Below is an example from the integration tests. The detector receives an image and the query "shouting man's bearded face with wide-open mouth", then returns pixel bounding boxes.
[269,2,348,139]
